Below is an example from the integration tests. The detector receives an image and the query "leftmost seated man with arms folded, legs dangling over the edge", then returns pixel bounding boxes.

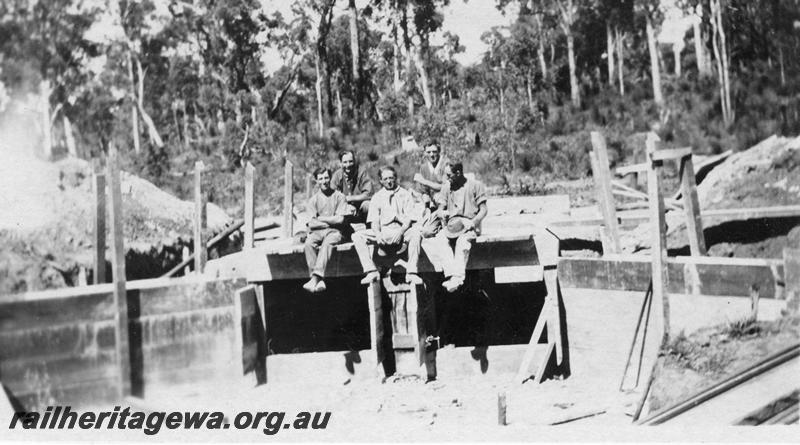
[303,167,347,292]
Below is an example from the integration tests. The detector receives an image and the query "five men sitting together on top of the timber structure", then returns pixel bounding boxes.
[303,140,486,292]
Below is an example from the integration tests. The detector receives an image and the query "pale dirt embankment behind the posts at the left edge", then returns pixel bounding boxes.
[0,153,230,294]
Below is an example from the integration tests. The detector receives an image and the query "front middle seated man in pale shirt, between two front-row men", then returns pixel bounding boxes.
[353,166,422,284]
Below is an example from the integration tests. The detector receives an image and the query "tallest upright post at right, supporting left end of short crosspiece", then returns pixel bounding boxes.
[646,132,669,338]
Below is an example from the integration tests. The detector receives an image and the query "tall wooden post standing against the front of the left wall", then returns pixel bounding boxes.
[107,144,131,400]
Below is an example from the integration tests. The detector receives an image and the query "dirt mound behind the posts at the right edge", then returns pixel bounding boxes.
[622,136,800,258]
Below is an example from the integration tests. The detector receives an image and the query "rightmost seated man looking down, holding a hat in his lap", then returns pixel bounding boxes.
[425,162,486,292]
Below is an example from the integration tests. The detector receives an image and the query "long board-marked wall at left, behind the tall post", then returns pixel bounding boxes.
[0,279,245,409]
